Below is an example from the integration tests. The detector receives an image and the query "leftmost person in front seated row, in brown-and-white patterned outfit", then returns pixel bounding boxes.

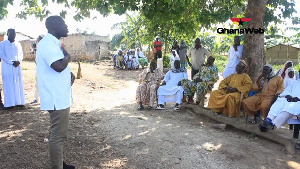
[136,61,164,110]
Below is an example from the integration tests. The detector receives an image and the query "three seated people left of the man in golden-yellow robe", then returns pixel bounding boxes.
[136,56,219,110]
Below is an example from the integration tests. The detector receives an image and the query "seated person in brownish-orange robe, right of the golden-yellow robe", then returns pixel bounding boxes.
[243,64,284,123]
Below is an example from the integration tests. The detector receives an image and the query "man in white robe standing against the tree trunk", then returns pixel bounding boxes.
[222,36,243,79]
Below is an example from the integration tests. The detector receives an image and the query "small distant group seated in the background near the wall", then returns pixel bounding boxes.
[113,48,148,70]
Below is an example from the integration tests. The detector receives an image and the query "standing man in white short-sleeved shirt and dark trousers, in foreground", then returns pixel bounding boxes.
[36,16,75,169]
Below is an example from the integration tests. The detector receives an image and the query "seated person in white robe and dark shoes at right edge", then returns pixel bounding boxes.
[259,80,300,131]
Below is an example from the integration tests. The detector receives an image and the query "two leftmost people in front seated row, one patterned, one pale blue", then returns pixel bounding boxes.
[136,60,188,110]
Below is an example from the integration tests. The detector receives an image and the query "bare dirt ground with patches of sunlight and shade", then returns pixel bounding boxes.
[0,62,300,169]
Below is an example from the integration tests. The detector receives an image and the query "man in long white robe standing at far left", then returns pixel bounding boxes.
[0,29,25,108]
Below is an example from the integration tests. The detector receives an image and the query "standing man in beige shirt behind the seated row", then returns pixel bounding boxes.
[186,38,210,79]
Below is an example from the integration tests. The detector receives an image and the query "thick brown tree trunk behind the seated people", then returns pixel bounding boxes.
[243,0,268,82]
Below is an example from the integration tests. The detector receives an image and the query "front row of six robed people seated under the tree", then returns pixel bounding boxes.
[136,56,300,131]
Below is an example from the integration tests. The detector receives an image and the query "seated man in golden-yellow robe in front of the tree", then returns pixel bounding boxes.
[208,60,253,117]
